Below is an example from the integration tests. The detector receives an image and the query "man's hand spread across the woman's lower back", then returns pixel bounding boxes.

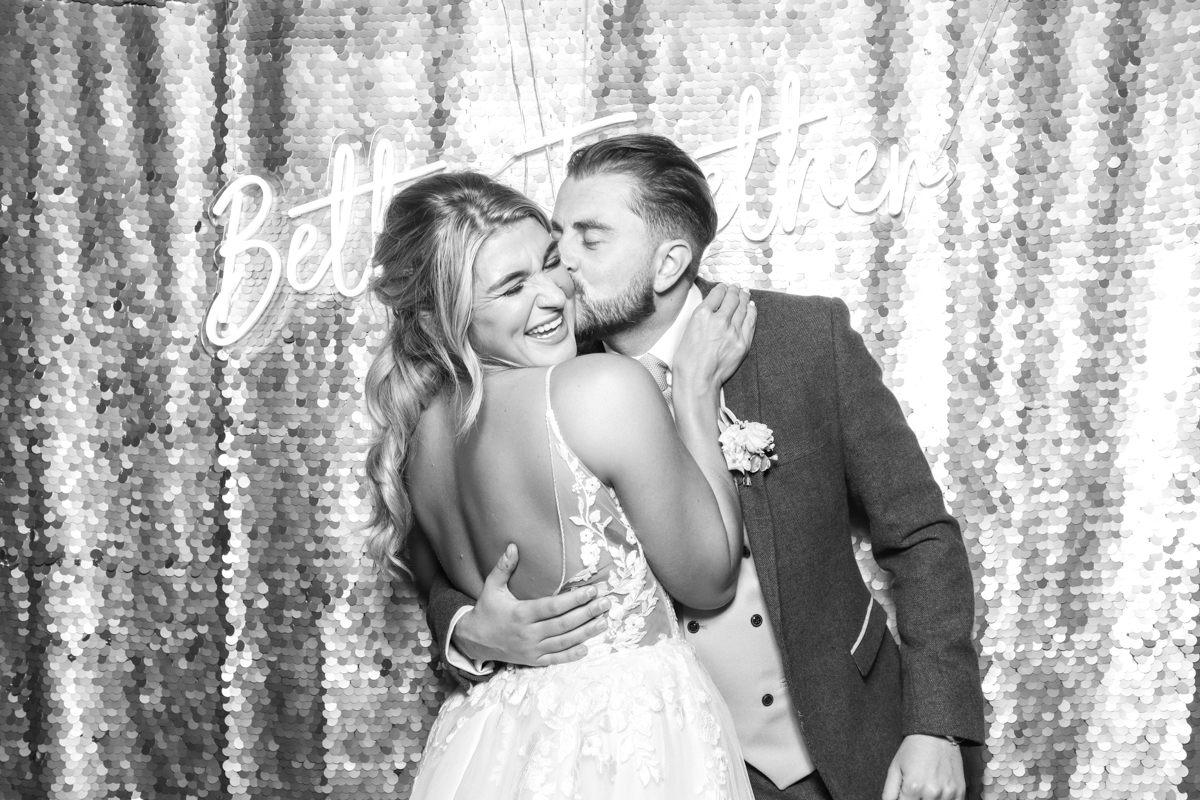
[452,545,612,667]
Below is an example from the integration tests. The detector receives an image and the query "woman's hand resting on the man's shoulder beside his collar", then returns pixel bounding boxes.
[672,283,758,398]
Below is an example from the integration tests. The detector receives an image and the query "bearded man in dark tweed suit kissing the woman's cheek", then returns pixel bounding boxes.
[427,134,984,800]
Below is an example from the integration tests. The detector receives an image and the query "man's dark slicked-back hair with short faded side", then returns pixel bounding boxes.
[566,133,716,281]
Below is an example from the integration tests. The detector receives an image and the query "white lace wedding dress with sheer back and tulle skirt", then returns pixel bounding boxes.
[410,369,754,800]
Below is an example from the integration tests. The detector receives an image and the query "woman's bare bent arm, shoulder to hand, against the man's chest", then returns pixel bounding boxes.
[554,285,757,608]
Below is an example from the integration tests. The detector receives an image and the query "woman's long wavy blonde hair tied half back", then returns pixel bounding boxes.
[365,173,550,577]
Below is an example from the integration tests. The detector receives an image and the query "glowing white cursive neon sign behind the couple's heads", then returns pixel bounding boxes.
[204,72,950,348]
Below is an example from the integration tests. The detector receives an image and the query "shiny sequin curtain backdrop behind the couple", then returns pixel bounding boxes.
[0,0,1200,800]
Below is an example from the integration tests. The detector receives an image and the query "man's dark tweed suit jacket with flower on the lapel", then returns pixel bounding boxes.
[427,281,984,800]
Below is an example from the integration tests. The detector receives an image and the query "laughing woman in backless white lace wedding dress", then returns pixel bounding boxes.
[366,173,755,800]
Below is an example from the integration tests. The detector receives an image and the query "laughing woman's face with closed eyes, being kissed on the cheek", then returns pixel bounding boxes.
[470,218,575,367]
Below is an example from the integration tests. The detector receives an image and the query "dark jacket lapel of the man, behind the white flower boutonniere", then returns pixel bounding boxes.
[706,307,782,645]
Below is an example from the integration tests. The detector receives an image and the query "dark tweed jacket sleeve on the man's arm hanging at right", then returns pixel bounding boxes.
[830,300,985,744]
